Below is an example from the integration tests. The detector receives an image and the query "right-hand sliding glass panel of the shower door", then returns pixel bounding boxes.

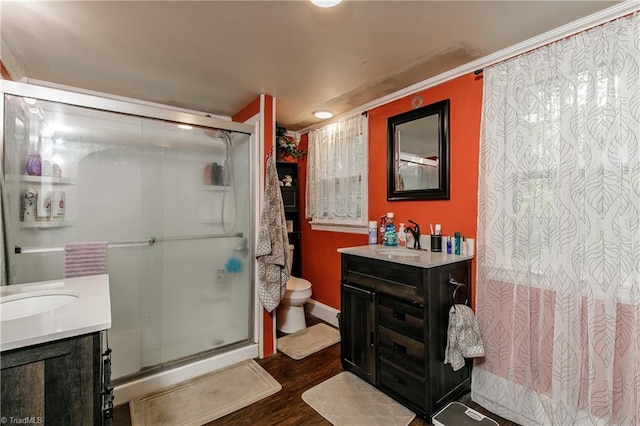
[142,119,251,363]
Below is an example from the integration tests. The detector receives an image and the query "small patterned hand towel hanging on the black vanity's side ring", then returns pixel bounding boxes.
[444,305,484,371]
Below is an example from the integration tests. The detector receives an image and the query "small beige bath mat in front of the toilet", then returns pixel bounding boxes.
[276,324,340,360]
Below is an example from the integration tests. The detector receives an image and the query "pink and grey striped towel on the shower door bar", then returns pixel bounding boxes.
[64,241,107,278]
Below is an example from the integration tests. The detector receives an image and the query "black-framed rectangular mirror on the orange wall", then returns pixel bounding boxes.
[387,99,449,201]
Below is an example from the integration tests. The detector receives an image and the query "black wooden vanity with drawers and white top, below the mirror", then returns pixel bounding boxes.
[338,245,473,419]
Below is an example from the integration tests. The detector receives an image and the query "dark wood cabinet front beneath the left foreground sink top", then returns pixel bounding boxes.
[0,332,103,426]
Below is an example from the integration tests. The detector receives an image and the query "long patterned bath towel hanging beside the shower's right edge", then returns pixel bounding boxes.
[256,155,289,312]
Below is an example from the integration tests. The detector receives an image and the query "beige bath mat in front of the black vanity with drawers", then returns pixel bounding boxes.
[302,371,416,426]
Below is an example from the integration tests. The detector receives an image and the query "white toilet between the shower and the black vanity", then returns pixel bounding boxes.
[276,244,311,334]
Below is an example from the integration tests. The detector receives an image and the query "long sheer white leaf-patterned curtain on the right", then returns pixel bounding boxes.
[472,13,640,425]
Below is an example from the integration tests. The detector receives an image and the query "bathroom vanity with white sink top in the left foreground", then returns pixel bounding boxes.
[0,275,111,426]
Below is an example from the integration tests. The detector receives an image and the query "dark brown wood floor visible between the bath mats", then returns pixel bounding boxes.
[113,317,517,426]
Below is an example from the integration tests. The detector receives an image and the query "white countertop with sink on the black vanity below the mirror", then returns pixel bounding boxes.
[338,244,473,268]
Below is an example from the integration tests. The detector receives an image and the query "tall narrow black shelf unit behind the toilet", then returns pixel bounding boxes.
[276,161,302,277]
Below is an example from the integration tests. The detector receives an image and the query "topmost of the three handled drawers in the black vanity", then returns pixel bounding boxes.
[378,295,424,342]
